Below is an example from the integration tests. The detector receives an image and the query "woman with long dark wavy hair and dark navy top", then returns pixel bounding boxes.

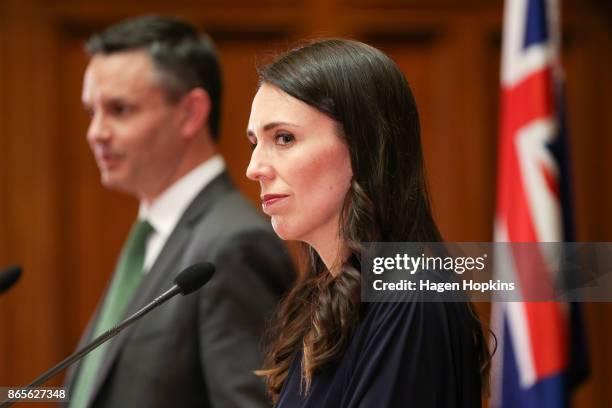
[247,39,489,408]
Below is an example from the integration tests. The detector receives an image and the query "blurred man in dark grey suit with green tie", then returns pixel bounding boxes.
[67,16,293,408]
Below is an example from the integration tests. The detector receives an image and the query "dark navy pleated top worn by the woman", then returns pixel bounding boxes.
[276,302,481,408]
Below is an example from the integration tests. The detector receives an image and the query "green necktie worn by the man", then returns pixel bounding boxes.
[70,220,153,408]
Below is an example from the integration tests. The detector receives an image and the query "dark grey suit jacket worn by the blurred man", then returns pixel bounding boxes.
[66,173,294,408]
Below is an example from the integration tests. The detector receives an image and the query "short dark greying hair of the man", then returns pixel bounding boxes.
[85,15,221,140]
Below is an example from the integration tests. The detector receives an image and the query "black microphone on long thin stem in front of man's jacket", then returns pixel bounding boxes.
[0,262,215,408]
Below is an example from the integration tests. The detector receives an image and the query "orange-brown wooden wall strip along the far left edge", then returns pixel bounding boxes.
[0,1,62,385]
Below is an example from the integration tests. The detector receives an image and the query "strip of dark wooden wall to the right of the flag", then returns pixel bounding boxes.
[563,9,612,407]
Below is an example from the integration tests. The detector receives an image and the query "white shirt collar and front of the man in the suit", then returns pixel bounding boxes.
[138,154,225,273]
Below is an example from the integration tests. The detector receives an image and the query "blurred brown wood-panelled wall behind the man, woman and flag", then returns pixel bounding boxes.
[0,0,612,407]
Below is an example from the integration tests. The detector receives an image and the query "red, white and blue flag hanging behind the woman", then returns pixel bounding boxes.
[491,0,588,408]
